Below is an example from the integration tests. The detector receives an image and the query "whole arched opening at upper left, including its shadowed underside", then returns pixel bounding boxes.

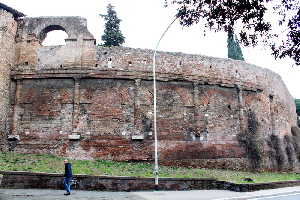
[40,25,68,46]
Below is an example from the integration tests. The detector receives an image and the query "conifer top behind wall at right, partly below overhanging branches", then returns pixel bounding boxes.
[227,28,245,61]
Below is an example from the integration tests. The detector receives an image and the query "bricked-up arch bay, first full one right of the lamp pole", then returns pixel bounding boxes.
[196,86,238,141]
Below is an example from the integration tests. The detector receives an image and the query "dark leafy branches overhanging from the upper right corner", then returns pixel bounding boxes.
[165,0,300,65]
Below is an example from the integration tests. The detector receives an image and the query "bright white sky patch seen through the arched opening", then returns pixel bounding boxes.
[42,30,68,46]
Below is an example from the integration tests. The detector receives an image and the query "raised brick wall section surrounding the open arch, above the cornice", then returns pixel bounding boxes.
[16,17,95,69]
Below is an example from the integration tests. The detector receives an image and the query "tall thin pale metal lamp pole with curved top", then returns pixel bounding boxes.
[153,15,179,191]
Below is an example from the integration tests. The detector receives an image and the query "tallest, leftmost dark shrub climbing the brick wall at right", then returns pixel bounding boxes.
[237,111,263,170]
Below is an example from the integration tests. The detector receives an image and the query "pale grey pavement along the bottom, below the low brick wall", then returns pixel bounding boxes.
[0,186,300,200]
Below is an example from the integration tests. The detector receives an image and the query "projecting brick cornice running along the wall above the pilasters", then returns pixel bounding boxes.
[10,66,263,91]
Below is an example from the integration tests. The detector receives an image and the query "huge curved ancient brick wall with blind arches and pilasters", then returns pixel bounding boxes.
[0,3,297,170]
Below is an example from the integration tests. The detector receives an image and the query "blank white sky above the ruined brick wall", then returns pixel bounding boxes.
[0,0,300,99]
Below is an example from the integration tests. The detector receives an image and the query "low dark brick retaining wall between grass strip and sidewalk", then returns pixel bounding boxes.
[0,171,300,192]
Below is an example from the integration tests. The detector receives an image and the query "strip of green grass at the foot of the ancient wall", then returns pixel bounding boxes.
[0,152,300,183]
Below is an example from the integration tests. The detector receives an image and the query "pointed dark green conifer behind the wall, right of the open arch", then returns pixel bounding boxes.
[100,4,125,47]
